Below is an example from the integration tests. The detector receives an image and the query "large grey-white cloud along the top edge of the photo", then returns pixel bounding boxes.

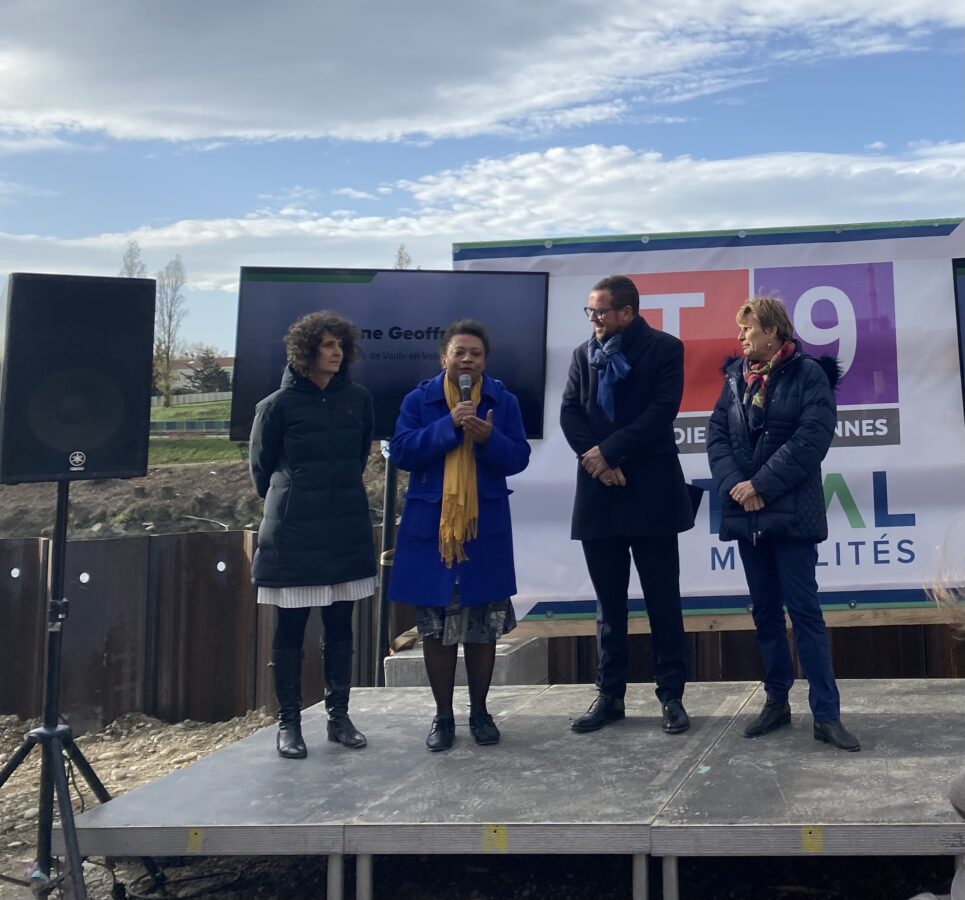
[0,0,965,142]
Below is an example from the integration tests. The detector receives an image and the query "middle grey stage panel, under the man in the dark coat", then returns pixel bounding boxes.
[345,683,753,854]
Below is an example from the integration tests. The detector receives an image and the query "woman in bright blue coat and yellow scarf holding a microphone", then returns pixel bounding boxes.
[389,319,529,751]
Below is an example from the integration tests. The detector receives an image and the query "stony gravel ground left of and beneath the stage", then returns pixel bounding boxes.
[0,710,952,900]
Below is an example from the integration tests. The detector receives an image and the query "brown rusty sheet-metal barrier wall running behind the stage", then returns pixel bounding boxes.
[0,531,965,734]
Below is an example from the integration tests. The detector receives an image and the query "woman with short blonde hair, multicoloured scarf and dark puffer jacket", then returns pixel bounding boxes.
[707,297,860,750]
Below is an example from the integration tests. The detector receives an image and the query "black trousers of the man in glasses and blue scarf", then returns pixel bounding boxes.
[582,534,687,703]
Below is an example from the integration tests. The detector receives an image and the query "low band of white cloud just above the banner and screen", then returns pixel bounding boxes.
[0,142,965,278]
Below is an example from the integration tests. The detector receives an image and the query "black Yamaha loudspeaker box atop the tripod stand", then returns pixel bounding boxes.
[0,272,155,484]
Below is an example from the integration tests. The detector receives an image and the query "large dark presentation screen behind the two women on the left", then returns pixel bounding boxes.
[231,267,548,441]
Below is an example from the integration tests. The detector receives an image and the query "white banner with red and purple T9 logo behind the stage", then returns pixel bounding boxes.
[453,220,965,616]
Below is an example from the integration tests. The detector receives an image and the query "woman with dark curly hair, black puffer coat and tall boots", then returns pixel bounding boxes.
[249,310,375,759]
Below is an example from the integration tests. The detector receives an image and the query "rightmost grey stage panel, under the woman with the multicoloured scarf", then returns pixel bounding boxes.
[651,679,965,856]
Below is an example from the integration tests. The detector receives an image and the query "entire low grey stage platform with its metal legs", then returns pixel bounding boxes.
[68,680,965,900]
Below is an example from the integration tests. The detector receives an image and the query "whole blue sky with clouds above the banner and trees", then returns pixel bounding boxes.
[0,0,965,351]
